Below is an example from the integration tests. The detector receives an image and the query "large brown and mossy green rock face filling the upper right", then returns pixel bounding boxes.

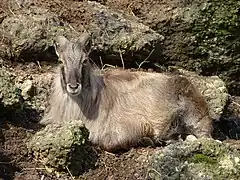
[105,0,240,95]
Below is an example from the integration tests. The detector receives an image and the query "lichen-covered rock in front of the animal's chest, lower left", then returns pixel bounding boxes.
[28,121,95,174]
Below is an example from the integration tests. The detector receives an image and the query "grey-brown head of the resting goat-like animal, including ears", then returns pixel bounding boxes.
[55,33,90,96]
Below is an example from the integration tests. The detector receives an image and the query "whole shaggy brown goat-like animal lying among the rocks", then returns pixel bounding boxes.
[41,34,212,151]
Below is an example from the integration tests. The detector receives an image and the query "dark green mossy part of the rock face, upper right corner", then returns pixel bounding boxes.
[176,0,240,95]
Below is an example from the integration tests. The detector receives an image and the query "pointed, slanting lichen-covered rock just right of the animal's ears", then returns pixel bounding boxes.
[88,1,164,58]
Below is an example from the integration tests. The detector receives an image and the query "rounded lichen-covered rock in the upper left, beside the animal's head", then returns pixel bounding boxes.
[0,8,74,60]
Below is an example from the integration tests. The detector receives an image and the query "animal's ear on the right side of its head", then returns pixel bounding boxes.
[76,32,91,53]
